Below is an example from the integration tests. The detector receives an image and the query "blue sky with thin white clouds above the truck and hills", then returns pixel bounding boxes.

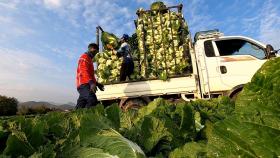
[0,0,280,103]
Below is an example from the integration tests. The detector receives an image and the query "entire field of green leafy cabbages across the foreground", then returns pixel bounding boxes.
[0,58,280,158]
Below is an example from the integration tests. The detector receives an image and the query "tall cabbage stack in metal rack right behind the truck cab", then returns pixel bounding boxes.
[136,2,190,80]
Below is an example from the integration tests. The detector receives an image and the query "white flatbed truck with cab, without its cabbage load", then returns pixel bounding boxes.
[97,30,276,107]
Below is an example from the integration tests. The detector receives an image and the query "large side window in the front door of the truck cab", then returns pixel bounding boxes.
[216,39,265,59]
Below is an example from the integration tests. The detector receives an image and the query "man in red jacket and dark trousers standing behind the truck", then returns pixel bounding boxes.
[76,43,104,109]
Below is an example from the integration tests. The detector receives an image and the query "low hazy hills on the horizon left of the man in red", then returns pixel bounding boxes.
[19,101,75,110]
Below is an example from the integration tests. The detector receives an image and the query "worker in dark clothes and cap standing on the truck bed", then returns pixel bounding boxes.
[117,34,134,81]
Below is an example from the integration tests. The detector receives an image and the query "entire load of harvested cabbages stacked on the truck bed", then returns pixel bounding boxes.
[95,2,190,84]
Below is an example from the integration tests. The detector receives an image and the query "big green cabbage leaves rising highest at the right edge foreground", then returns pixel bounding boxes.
[170,58,280,157]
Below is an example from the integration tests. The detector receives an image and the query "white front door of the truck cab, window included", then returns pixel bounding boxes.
[213,39,266,90]
